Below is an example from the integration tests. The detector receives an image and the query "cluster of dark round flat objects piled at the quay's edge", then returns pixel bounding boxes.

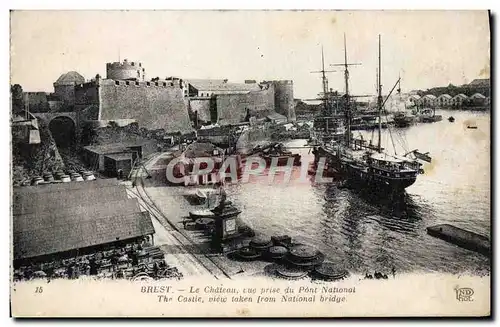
[231,235,349,281]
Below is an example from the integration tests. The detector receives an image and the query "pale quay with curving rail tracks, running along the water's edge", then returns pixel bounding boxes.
[128,154,348,280]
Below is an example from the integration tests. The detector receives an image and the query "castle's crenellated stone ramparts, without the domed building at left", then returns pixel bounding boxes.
[74,66,295,132]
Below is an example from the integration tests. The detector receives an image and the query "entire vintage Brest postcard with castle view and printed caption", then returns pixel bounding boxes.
[10,10,492,317]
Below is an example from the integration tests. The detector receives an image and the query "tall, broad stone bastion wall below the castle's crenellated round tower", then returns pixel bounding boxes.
[99,80,191,132]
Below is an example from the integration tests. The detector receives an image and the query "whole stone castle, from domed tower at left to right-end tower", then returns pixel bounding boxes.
[26,60,295,132]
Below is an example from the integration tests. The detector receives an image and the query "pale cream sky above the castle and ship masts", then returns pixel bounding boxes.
[11,11,490,99]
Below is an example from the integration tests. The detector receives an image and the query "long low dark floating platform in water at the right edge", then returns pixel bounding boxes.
[427,224,491,256]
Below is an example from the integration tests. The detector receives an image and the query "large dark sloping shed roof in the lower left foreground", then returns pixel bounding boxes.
[13,180,154,259]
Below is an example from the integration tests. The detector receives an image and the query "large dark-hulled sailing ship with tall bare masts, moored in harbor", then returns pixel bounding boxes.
[313,35,431,193]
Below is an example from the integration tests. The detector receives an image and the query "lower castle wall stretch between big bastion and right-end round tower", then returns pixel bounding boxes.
[216,84,275,125]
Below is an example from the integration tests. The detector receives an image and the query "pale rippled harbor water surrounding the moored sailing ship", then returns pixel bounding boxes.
[227,110,491,275]
